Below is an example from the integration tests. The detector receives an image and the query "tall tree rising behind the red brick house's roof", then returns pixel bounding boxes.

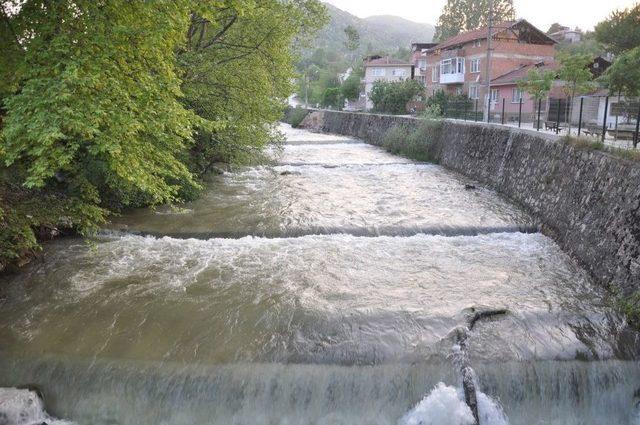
[434,0,516,41]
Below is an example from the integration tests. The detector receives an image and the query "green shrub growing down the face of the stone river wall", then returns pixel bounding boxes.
[382,120,442,162]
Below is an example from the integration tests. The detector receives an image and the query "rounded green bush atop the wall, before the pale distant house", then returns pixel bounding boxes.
[370,80,424,114]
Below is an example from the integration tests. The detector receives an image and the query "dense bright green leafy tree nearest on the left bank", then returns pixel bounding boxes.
[3,0,198,202]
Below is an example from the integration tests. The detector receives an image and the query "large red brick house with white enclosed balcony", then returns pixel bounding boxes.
[419,19,556,107]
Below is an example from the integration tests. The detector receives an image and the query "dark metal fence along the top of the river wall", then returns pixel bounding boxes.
[442,95,640,149]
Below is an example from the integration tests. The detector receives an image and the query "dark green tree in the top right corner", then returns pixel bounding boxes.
[595,3,640,54]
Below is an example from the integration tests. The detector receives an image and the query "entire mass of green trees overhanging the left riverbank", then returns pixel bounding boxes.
[0,0,326,268]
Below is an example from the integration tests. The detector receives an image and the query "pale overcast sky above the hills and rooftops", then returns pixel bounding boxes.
[325,0,637,31]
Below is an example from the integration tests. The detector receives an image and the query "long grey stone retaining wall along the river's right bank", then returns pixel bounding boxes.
[303,111,640,293]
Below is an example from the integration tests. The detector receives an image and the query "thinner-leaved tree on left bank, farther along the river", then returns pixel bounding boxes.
[178,0,326,174]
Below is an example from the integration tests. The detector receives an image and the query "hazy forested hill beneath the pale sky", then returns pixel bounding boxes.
[312,3,435,54]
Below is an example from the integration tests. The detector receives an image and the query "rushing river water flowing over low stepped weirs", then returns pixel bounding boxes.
[0,124,640,425]
